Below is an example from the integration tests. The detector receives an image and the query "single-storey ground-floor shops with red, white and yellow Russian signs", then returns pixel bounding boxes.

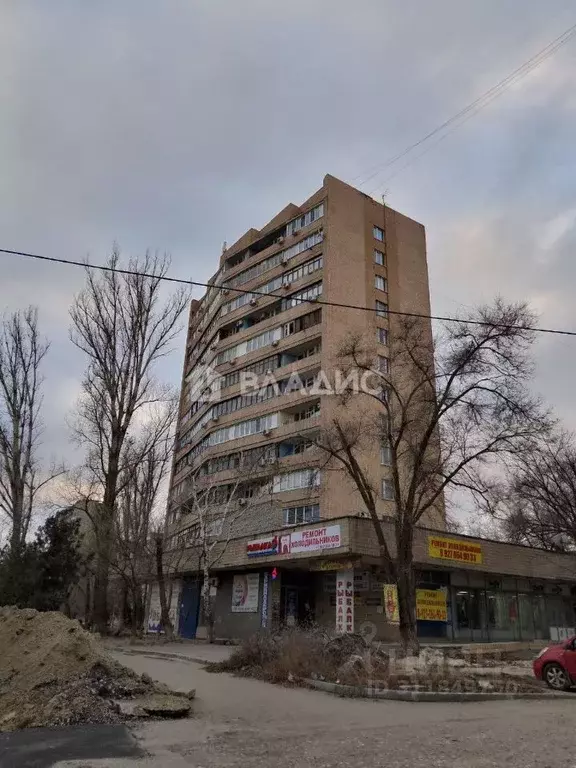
[153,518,576,643]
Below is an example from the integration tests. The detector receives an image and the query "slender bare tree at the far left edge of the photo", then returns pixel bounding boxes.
[0,307,62,555]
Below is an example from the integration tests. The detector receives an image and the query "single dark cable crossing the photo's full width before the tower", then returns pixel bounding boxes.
[0,248,576,336]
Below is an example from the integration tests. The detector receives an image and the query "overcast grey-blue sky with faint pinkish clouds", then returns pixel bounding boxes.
[0,0,576,480]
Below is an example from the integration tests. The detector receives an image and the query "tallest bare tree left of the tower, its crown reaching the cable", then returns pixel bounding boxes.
[70,248,187,632]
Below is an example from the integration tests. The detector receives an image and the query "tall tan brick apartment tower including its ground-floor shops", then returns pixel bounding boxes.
[162,176,576,640]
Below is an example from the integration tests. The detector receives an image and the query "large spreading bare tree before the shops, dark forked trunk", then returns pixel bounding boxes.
[310,300,548,652]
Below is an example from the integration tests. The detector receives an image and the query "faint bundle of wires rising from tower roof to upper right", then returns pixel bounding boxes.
[352,24,576,186]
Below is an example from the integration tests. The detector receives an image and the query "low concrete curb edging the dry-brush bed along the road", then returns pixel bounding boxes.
[304,680,570,702]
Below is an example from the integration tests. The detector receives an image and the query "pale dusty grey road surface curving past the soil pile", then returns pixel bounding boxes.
[0,654,576,768]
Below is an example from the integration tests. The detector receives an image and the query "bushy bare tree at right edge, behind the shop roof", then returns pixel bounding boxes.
[484,432,576,552]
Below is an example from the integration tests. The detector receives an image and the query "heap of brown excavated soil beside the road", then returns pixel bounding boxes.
[0,607,194,731]
